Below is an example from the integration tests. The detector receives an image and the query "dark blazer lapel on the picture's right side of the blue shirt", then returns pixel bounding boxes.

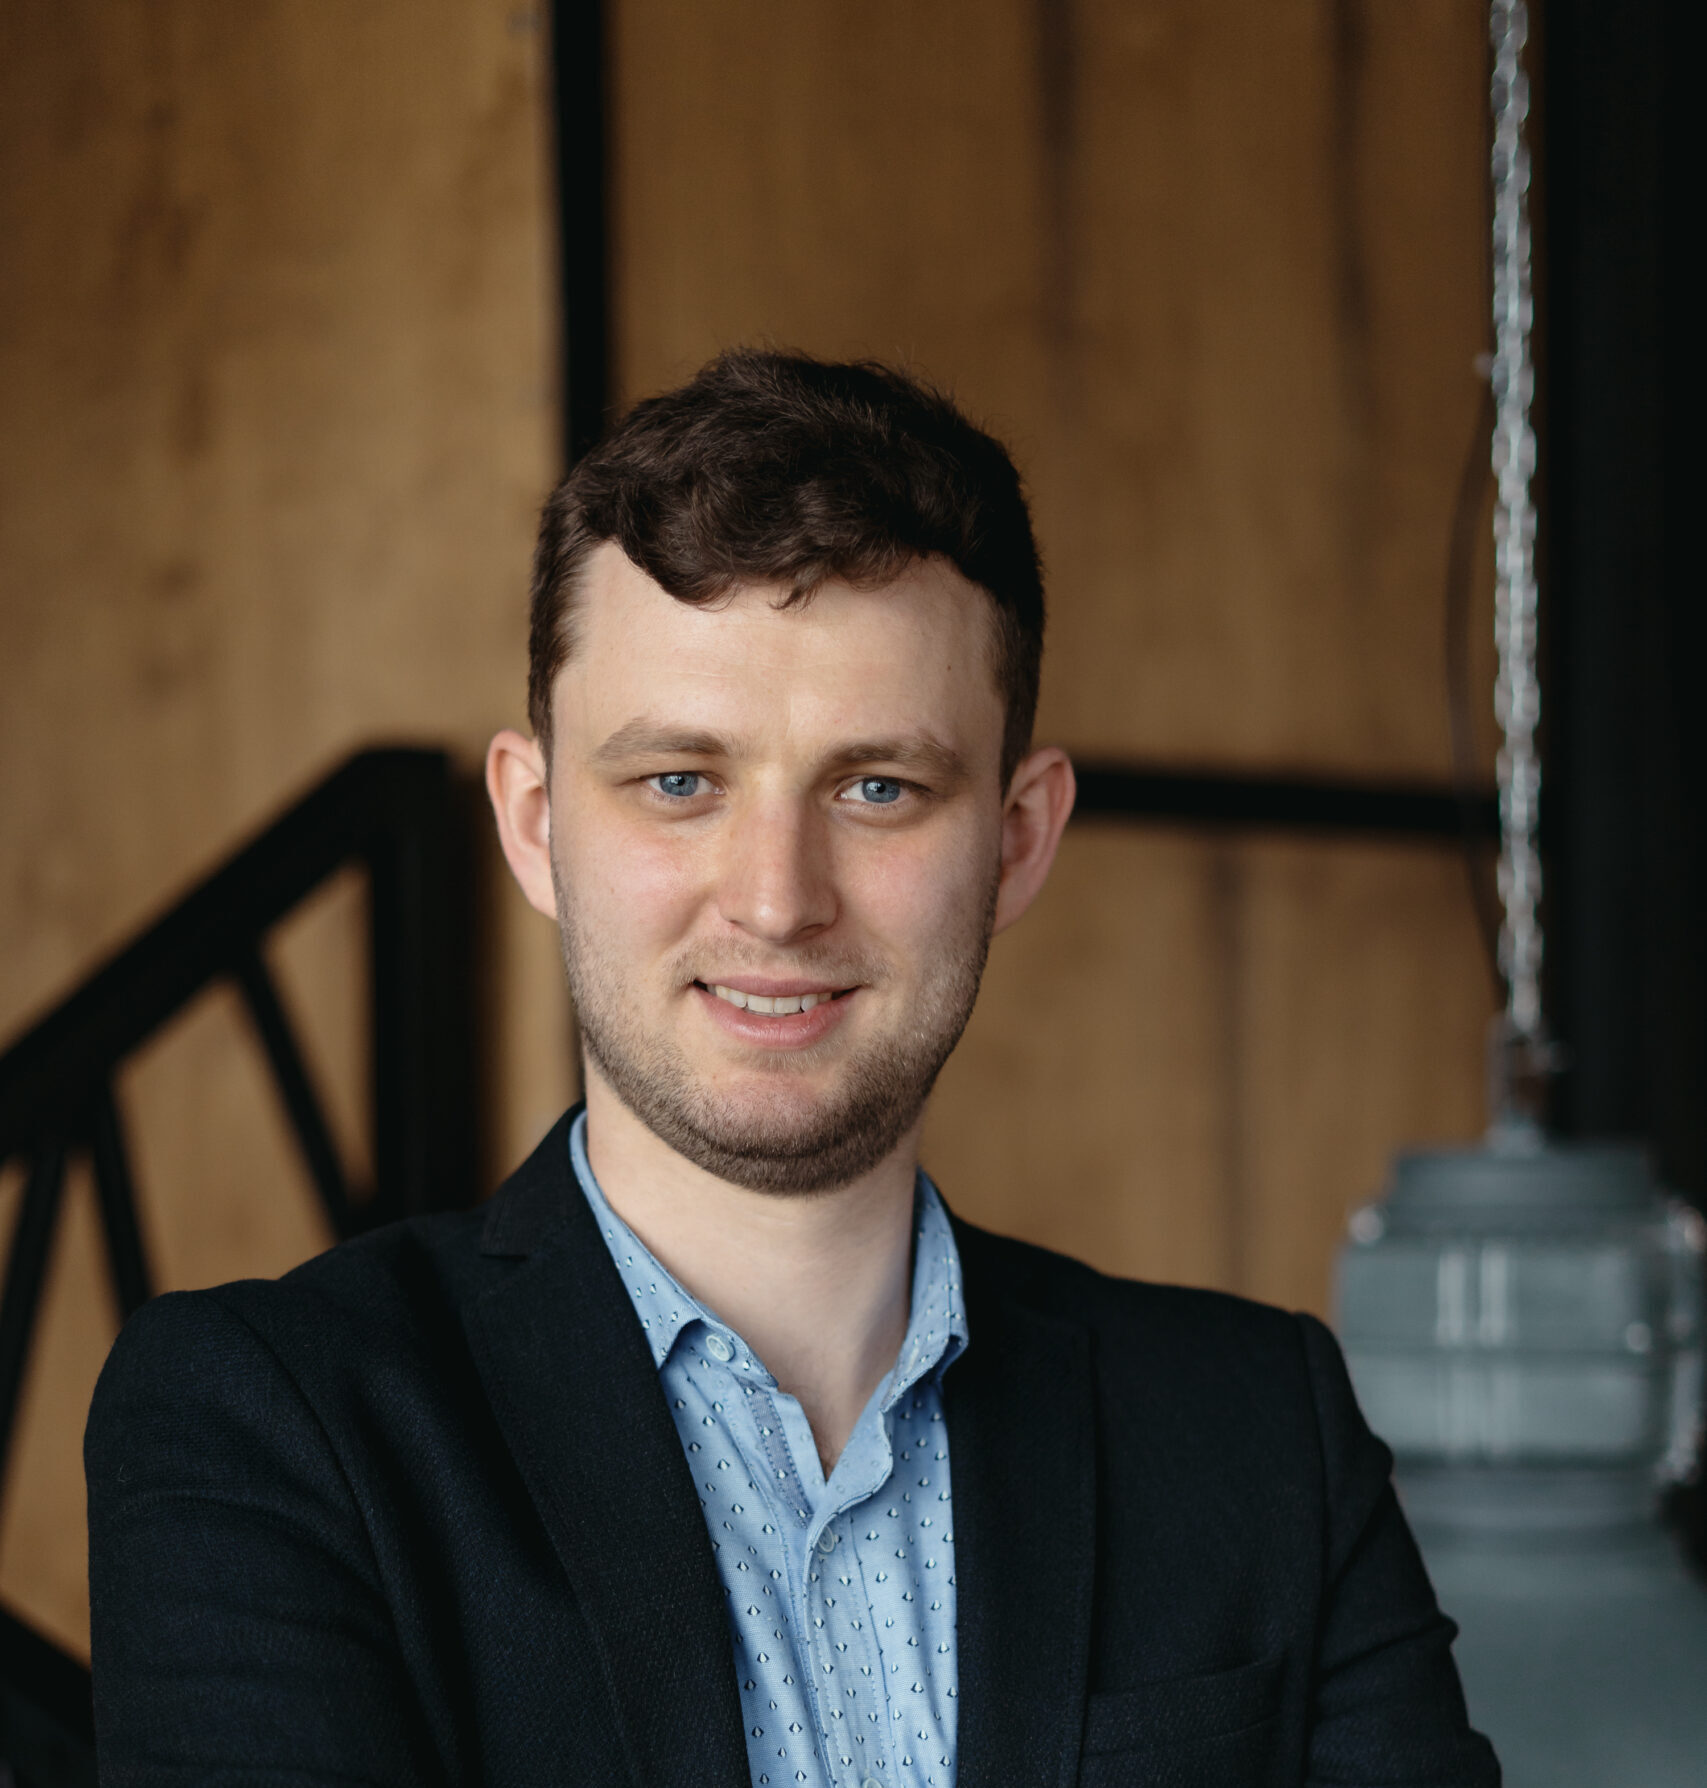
[944,1223,1096,1788]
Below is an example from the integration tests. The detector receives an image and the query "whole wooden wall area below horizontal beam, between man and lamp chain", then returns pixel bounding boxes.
[924,826,1489,1316]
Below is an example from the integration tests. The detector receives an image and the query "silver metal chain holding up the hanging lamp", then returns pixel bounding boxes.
[1489,0,1541,1037]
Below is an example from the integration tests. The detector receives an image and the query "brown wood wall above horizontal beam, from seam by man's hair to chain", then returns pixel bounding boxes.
[1035,0,1485,776]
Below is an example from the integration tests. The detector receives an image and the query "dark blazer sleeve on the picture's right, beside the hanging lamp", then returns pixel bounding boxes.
[1298,1316,1500,1788]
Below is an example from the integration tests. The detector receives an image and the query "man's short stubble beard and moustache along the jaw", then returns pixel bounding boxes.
[552,862,997,1194]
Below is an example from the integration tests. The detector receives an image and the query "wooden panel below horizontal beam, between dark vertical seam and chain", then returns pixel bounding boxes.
[1226,840,1493,1316]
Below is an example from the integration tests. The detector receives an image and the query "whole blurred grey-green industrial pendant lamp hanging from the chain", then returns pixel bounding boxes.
[1339,1132,1707,1788]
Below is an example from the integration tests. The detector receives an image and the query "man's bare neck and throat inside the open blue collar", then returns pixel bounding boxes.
[586,1066,919,1477]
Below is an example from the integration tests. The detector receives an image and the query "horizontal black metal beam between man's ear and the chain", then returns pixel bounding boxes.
[1074,762,1500,844]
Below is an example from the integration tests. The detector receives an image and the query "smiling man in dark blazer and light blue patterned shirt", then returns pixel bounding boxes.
[88,354,1498,1788]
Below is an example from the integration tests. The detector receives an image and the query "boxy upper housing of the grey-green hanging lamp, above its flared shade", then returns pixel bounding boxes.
[1339,1141,1703,1532]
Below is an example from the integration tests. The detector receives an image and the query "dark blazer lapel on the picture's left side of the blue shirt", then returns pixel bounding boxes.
[463,1112,749,1788]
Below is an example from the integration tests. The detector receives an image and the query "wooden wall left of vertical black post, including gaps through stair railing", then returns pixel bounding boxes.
[0,0,570,1643]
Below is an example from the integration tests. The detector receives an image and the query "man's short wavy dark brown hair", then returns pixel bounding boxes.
[527,349,1044,787]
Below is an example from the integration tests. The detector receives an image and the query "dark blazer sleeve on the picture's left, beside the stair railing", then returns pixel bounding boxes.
[84,1291,434,1788]
